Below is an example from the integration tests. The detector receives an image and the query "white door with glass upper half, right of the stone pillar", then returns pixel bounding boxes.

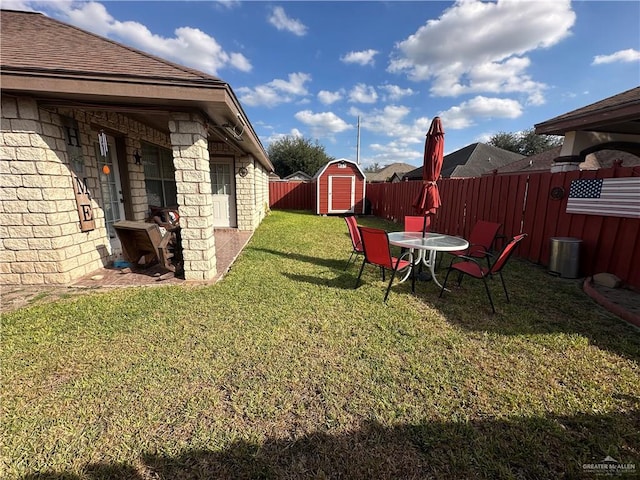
[210,158,237,227]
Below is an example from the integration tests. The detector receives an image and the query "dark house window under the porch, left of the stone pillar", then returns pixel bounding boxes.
[142,142,178,207]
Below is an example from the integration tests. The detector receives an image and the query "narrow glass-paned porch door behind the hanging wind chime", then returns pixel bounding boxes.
[95,136,124,256]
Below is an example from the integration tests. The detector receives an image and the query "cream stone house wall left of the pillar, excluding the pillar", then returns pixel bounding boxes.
[0,95,169,285]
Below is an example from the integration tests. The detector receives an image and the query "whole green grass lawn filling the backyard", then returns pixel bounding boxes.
[0,211,640,480]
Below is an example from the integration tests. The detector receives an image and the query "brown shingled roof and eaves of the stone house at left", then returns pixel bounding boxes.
[0,10,273,170]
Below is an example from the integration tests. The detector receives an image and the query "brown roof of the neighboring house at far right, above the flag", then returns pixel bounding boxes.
[535,87,640,135]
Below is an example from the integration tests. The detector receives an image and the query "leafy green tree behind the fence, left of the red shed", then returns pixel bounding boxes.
[267,136,334,177]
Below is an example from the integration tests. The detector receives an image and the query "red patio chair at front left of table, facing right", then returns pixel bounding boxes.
[354,227,411,303]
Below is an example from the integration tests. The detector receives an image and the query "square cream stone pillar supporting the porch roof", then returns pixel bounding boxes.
[169,113,216,281]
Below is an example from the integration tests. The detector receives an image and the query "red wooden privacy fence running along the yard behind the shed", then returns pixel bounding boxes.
[270,167,640,289]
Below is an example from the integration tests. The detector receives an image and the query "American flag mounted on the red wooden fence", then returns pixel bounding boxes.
[567,177,640,218]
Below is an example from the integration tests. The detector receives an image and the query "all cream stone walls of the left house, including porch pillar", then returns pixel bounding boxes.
[0,95,268,285]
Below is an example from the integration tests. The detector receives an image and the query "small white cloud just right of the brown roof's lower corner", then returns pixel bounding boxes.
[237,72,311,107]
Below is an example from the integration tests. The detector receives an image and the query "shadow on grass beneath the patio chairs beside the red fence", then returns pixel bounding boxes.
[428,260,640,361]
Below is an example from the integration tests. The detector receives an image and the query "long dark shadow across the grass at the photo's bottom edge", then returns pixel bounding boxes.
[22,408,640,480]
